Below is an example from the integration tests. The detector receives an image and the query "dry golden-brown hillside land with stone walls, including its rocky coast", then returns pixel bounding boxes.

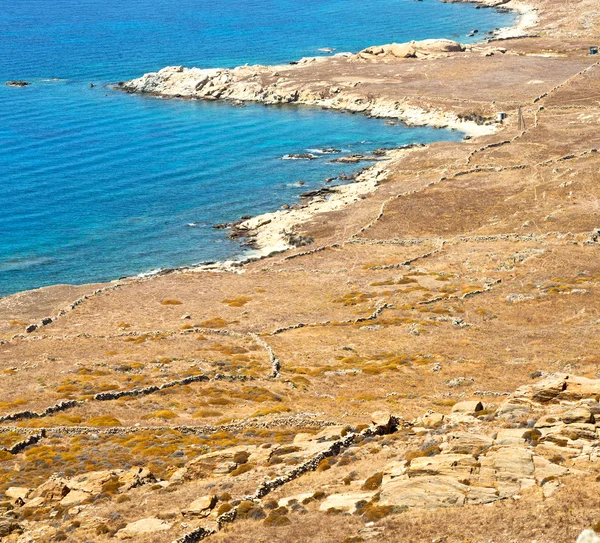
[0,0,600,543]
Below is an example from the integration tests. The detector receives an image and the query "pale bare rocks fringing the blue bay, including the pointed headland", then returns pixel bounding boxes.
[116,0,537,262]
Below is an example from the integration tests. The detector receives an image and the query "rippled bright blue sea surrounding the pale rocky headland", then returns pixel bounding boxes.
[0,0,513,296]
